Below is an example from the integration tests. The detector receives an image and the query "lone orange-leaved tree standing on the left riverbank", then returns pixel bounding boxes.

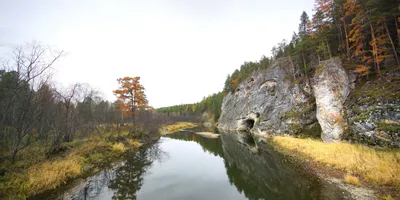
[113,76,150,122]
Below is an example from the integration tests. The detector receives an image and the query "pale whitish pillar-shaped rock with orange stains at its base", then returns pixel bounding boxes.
[313,58,350,142]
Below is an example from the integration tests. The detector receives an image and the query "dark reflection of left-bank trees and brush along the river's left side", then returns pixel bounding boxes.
[30,144,168,200]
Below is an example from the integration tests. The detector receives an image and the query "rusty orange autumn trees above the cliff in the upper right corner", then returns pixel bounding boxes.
[336,0,400,76]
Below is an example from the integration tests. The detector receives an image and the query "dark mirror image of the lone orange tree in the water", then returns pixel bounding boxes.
[108,144,166,199]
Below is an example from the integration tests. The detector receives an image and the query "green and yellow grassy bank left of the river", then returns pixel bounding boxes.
[0,127,142,199]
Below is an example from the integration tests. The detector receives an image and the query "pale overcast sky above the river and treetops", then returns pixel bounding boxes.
[0,0,314,107]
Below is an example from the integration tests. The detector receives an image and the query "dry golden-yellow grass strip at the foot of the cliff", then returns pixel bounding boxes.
[273,136,400,188]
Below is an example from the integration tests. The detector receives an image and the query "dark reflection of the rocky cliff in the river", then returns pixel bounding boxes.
[221,133,342,199]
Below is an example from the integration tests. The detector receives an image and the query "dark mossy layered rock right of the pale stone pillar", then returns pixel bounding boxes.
[345,78,400,147]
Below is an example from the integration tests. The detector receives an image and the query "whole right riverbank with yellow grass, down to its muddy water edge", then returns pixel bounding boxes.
[271,136,400,199]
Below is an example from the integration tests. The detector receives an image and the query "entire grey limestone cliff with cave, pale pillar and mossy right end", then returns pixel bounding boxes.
[218,58,400,147]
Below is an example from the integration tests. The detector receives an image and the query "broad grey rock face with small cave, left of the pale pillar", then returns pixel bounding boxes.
[218,58,319,136]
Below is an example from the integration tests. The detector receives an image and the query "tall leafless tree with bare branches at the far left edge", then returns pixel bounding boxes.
[0,42,63,163]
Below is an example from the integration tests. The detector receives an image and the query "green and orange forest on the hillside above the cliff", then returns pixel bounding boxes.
[157,0,400,121]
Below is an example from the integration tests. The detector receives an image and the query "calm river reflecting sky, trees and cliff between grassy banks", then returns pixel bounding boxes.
[30,128,348,200]
